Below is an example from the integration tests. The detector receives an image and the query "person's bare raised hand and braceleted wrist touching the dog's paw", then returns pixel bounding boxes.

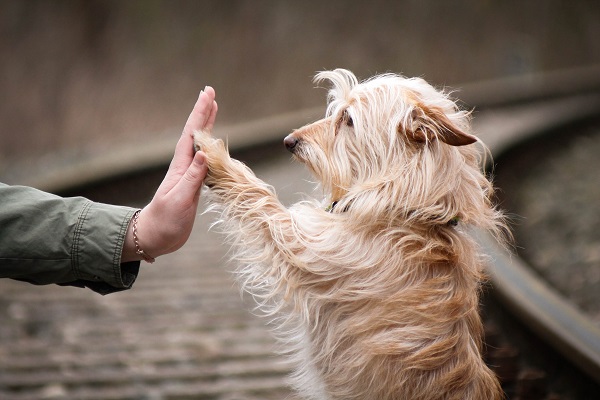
[121,86,218,262]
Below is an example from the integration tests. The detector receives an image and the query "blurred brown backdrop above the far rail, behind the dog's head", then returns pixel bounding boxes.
[0,0,600,183]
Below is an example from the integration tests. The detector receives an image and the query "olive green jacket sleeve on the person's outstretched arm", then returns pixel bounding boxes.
[0,183,140,294]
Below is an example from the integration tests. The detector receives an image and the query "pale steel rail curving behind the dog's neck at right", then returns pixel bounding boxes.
[473,93,600,383]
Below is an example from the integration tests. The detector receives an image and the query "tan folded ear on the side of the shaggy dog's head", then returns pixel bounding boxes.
[408,106,477,146]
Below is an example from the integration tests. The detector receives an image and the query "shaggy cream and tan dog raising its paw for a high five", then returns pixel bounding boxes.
[194,69,506,400]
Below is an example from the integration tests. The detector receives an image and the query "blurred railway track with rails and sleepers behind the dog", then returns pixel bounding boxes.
[0,67,600,400]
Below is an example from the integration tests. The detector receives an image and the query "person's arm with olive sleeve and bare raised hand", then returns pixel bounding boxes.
[0,87,217,294]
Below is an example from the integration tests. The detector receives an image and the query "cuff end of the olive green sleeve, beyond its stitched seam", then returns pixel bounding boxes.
[71,202,140,294]
